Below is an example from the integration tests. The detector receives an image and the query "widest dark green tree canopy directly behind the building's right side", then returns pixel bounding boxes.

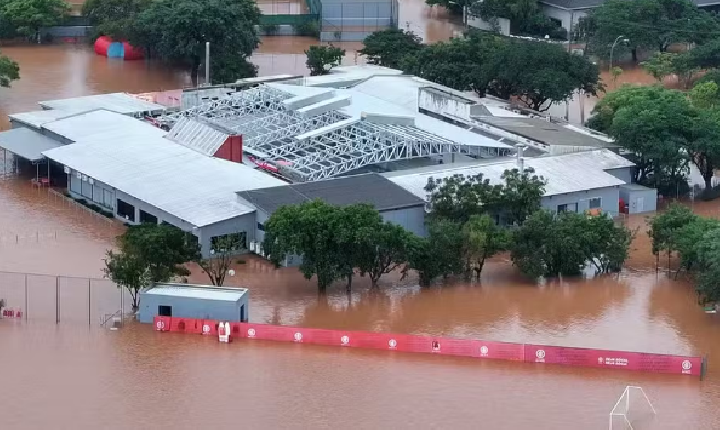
[399,31,604,111]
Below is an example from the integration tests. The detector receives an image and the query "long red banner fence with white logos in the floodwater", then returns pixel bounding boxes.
[154,317,706,378]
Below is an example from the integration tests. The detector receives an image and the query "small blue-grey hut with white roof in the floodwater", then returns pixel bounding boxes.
[140,284,249,323]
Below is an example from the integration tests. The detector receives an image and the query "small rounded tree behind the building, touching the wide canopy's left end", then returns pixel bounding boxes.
[358,28,423,69]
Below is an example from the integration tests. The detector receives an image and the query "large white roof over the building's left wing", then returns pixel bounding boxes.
[43,113,285,227]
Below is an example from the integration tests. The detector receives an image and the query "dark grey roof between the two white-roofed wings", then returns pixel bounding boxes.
[238,173,425,214]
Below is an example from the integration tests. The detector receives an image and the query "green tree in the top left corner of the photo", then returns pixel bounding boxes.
[0,0,70,40]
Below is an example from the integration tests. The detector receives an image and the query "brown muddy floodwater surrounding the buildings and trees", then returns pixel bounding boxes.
[0,0,720,430]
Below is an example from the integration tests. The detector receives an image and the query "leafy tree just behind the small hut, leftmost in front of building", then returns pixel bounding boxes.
[104,224,200,310]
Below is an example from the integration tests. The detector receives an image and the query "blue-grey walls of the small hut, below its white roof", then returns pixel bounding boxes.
[140,293,249,323]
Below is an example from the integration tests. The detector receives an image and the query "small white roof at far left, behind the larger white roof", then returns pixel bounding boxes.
[39,93,167,115]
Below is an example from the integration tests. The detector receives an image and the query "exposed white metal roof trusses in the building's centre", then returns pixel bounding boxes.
[166,86,508,182]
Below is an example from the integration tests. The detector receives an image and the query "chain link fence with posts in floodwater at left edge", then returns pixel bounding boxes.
[0,272,132,325]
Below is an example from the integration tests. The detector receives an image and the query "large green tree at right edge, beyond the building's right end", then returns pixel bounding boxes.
[588,83,720,195]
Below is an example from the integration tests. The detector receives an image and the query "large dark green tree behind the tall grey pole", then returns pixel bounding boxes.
[129,0,260,85]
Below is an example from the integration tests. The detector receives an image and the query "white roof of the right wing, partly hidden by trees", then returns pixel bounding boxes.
[386,149,633,199]
